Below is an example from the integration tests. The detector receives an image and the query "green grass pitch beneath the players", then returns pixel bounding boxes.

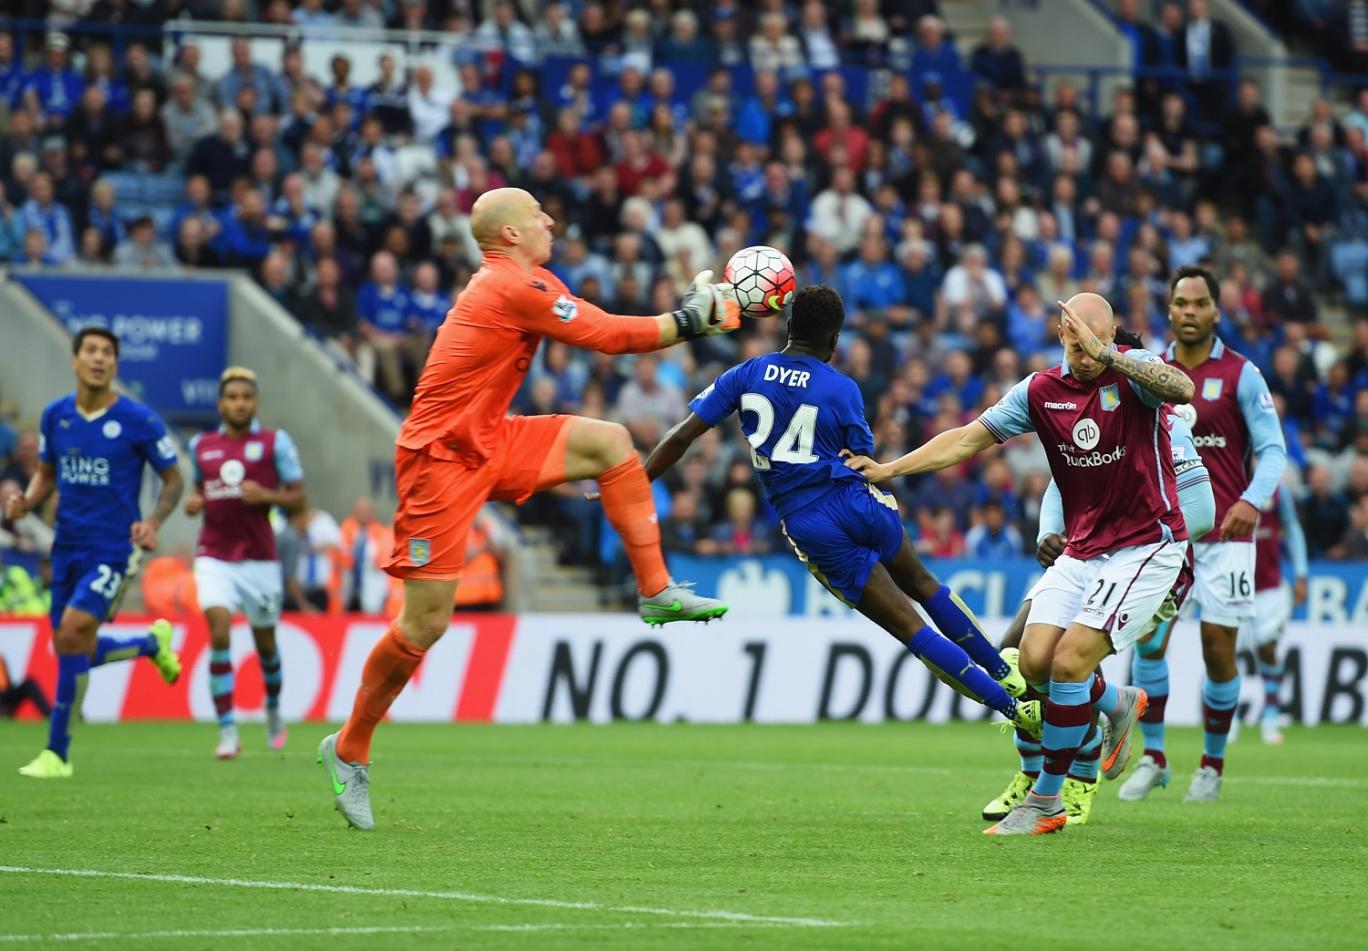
[0,724,1368,951]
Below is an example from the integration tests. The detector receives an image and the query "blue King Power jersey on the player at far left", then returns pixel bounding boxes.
[38,395,176,547]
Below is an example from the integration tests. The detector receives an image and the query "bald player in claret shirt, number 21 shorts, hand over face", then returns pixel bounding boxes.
[847,294,1193,835]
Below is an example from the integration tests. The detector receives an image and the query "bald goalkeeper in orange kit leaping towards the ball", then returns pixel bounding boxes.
[319,189,740,829]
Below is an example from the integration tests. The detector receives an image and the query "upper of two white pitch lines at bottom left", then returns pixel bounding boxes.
[0,865,855,928]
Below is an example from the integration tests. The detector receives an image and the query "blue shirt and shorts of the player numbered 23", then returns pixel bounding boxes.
[38,395,176,624]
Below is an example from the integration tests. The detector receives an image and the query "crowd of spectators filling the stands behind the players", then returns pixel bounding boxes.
[0,0,1368,582]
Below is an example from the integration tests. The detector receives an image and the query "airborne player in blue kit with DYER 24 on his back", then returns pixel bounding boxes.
[646,285,1040,736]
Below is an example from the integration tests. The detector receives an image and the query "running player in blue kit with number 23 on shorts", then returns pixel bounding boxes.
[5,327,185,779]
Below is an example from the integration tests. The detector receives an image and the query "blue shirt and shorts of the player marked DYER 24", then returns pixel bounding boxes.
[689,353,904,605]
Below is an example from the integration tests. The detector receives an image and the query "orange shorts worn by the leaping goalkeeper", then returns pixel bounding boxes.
[384,416,572,582]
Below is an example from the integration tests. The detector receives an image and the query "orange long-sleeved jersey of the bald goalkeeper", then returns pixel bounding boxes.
[398,255,661,468]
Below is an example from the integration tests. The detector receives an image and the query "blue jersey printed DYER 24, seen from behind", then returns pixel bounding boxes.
[689,353,874,516]
